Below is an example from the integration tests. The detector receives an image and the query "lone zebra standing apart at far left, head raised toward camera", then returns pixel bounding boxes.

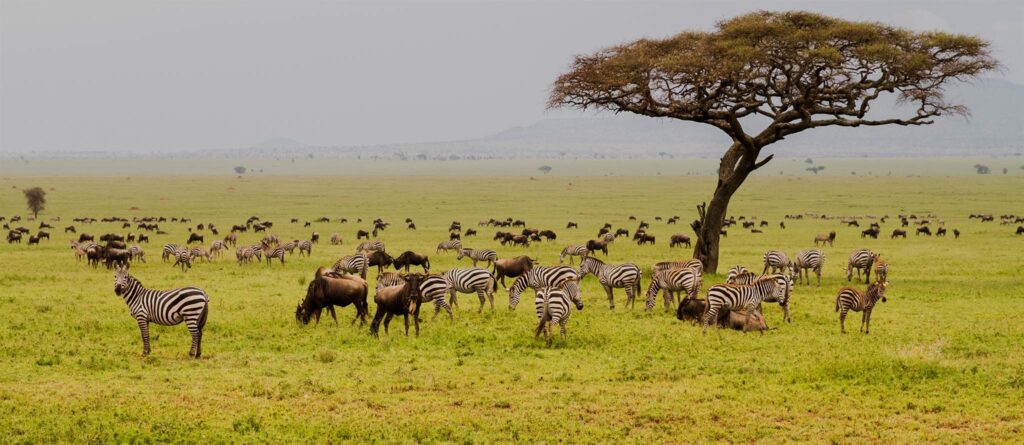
[114,267,210,358]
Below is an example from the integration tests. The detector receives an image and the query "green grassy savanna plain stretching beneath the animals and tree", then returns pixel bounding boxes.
[0,160,1024,443]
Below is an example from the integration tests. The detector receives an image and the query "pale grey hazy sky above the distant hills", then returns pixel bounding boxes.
[0,0,1024,151]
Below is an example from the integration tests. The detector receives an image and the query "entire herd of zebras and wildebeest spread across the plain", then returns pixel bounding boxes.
[0,213,1024,358]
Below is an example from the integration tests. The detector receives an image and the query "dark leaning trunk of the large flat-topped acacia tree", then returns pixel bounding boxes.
[693,143,757,273]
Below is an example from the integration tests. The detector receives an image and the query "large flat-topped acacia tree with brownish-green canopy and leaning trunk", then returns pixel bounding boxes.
[549,11,997,272]
